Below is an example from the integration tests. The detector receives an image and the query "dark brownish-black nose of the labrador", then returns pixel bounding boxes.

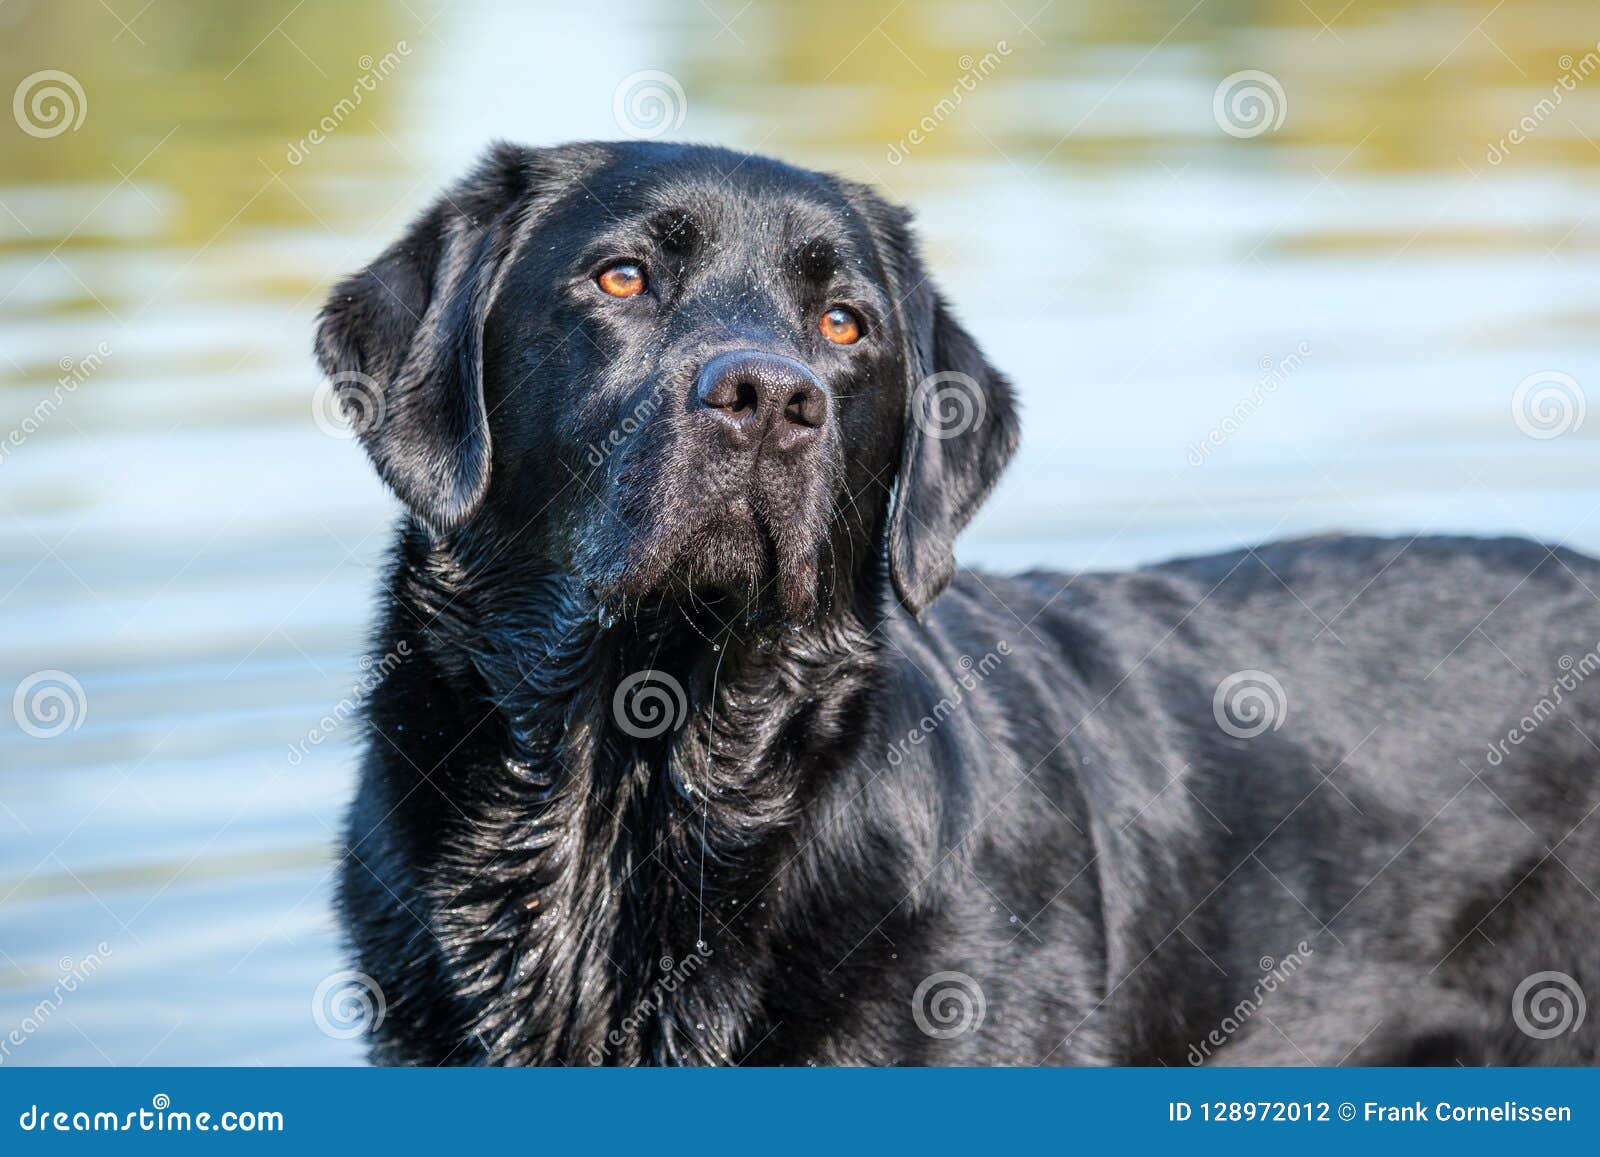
[694,349,827,450]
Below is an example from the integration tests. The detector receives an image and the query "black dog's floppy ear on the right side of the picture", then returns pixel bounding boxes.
[853,196,1018,615]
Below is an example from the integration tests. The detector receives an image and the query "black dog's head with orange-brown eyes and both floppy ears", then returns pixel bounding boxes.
[317,144,1016,621]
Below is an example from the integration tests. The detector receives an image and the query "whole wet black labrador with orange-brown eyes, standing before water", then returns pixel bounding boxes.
[317,144,1600,1064]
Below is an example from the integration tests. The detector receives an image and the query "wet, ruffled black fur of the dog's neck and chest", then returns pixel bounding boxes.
[384,528,875,1064]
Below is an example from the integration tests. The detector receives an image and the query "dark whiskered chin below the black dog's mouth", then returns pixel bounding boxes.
[597,504,818,624]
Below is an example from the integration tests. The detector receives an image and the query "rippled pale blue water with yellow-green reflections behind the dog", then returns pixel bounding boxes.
[0,0,1600,1064]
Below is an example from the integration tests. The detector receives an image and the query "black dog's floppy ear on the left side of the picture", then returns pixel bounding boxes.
[317,144,534,533]
